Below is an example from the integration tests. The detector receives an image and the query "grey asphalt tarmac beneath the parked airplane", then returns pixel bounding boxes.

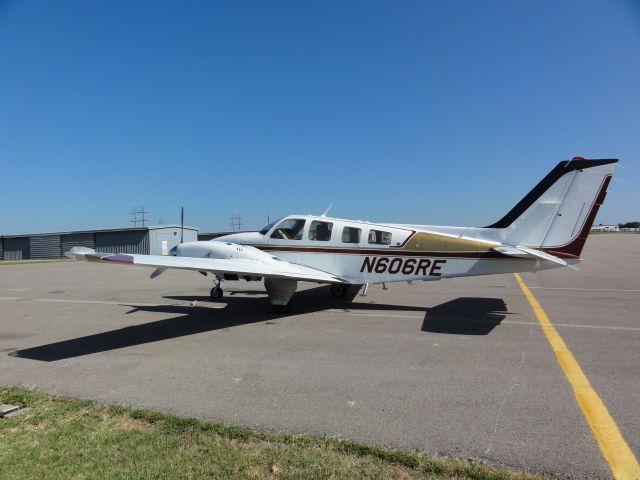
[0,234,640,478]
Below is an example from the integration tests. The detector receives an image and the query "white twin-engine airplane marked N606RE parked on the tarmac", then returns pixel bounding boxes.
[68,157,618,312]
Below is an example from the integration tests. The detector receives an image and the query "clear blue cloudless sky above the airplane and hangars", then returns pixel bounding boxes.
[0,0,640,234]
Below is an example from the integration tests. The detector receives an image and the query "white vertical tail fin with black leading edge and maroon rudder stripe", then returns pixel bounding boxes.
[485,157,618,259]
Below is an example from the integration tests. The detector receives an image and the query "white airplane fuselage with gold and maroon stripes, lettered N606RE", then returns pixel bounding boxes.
[180,215,568,284]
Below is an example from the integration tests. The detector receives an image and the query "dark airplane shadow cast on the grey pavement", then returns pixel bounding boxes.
[9,286,508,362]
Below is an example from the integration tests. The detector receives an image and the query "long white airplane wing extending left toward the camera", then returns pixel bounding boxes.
[66,247,347,283]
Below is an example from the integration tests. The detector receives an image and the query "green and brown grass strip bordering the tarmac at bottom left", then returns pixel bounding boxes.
[0,388,540,480]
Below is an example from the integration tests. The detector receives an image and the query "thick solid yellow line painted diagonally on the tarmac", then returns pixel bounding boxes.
[514,273,640,480]
